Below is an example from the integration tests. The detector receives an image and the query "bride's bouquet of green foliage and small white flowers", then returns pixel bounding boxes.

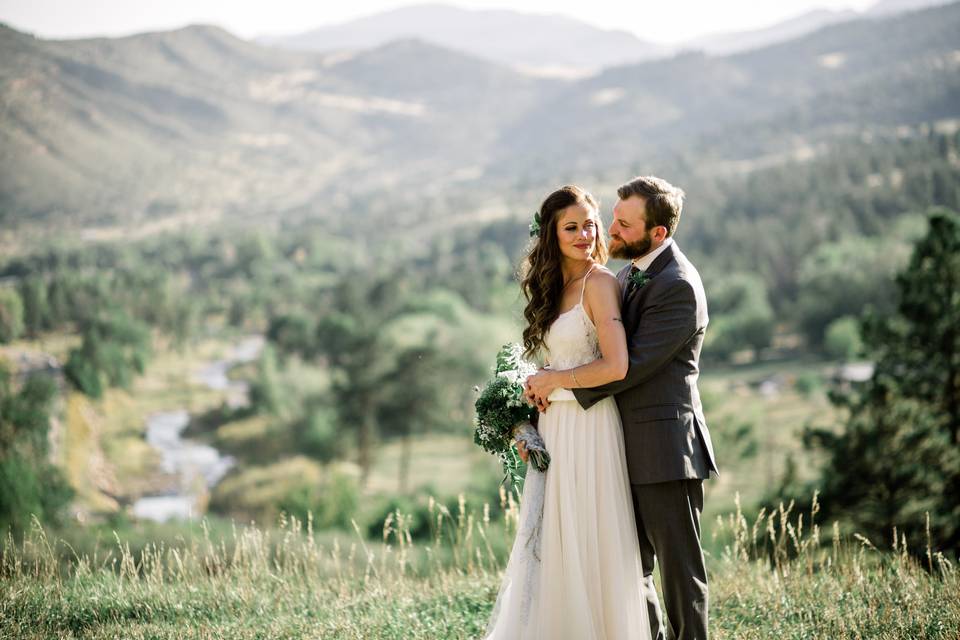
[473,343,550,482]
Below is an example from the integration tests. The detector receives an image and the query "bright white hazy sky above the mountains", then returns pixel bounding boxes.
[0,0,875,43]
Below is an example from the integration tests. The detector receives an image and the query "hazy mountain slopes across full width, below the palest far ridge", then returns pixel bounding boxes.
[0,4,960,233]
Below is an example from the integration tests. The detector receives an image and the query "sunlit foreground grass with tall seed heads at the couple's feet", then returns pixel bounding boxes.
[0,498,960,640]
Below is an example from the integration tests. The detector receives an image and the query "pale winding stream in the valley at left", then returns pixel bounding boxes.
[133,336,264,522]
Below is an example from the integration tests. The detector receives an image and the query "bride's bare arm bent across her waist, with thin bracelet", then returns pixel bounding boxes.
[527,271,629,398]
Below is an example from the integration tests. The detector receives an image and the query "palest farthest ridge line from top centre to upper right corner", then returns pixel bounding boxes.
[255,0,951,67]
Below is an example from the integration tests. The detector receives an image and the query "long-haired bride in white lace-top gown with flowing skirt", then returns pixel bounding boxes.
[486,186,650,640]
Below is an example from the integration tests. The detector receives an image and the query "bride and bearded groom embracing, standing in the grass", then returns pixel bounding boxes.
[486,177,717,640]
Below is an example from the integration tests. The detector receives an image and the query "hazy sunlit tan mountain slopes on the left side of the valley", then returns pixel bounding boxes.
[0,26,541,224]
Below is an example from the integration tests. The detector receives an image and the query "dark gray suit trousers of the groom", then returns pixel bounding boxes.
[630,479,707,640]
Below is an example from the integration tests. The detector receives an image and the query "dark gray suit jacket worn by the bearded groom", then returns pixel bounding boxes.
[573,242,717,484]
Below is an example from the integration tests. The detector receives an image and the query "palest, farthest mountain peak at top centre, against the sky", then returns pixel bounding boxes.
[260,4,670,73]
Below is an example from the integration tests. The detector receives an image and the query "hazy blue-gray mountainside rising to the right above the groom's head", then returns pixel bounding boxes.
[484,3,960,175]
